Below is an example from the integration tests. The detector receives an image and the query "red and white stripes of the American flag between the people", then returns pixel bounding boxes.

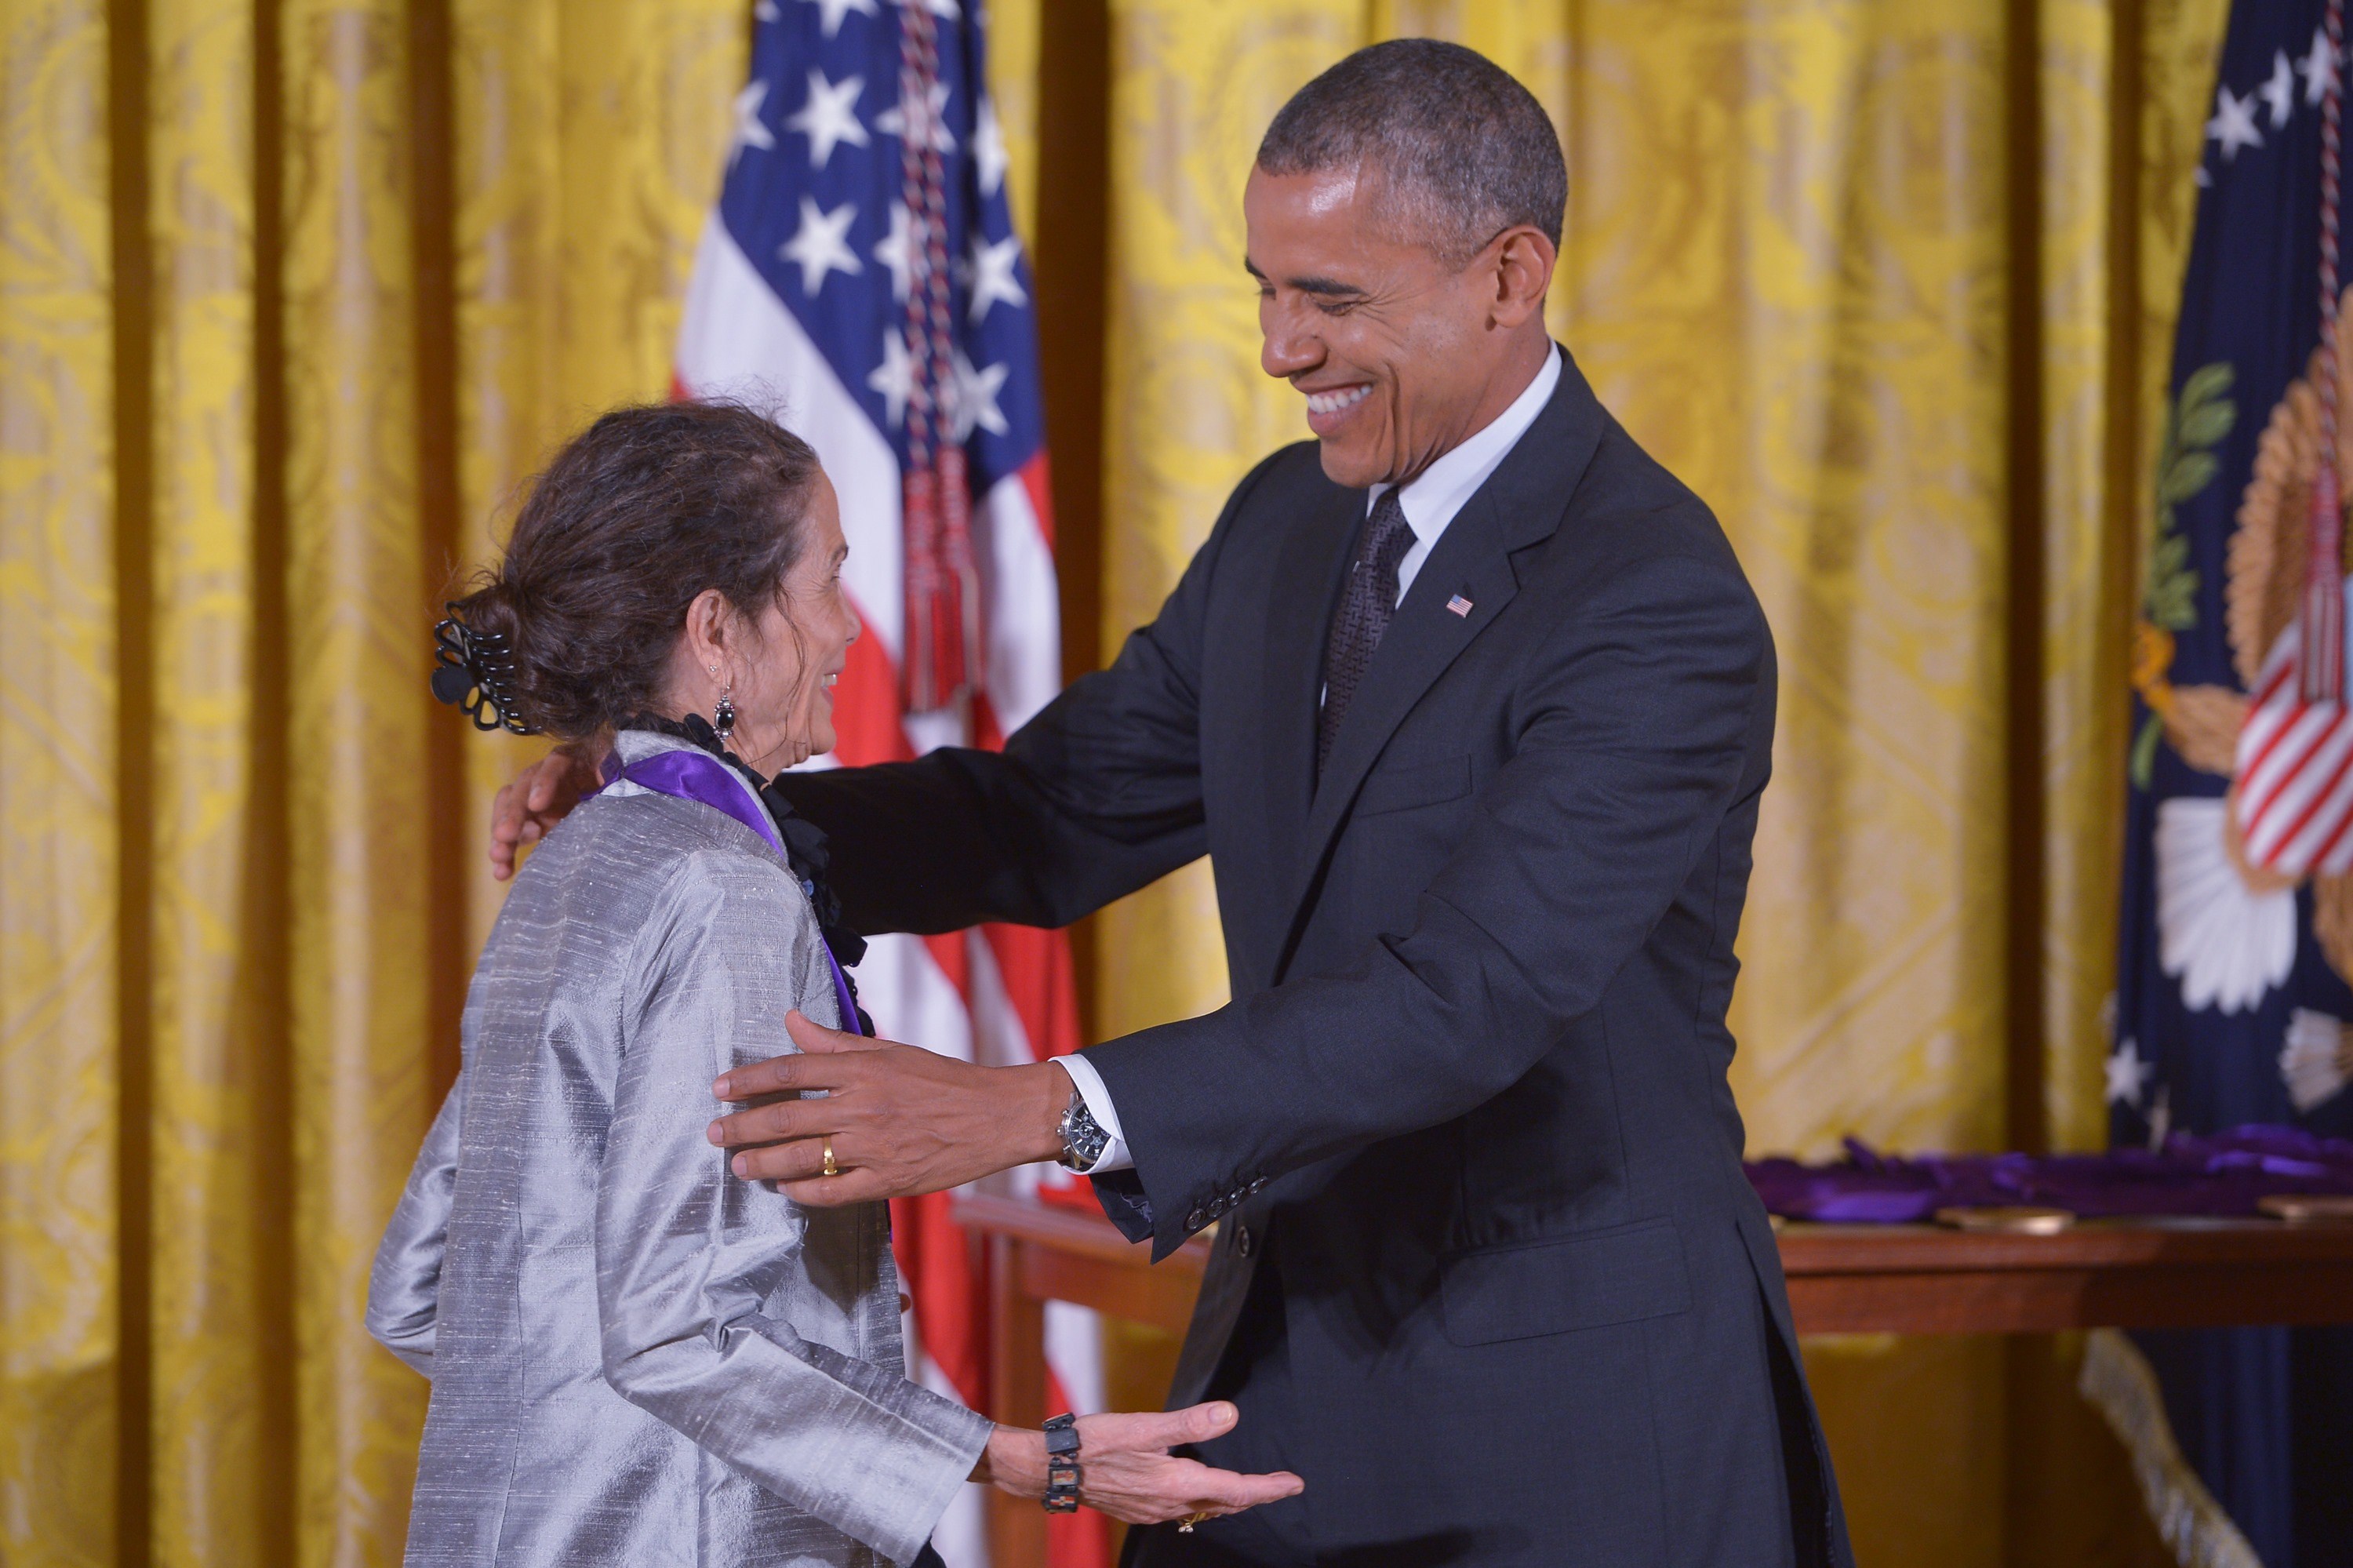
[678,216,1111,1568]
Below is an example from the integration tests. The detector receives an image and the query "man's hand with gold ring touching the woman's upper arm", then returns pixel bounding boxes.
[711,1013,1071,1206]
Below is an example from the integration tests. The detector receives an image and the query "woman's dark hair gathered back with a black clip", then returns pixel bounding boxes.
[452,402,819,739]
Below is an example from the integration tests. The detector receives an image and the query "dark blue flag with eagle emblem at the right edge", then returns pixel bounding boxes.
[2108,0,2353,1544]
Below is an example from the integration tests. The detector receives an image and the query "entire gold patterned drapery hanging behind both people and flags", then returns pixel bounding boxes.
[0,0,2224,1568]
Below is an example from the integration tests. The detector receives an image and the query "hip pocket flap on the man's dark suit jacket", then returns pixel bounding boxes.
[1440,1220,1692,1344]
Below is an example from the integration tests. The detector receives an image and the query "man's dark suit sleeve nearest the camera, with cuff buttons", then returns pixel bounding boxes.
[1085,544,1774,1255]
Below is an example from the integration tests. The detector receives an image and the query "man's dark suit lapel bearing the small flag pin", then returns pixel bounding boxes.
[1273,348,1607,980]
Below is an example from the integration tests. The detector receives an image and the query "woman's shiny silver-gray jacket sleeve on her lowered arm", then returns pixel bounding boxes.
[595,857,991,1563]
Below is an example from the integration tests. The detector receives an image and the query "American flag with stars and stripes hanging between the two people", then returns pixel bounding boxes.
[675,0,1108,1568]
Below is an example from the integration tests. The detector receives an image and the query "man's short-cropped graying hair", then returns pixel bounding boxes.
[1259,38,1569,266]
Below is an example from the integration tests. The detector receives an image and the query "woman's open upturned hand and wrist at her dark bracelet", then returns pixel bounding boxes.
[972,1401,1306,1523]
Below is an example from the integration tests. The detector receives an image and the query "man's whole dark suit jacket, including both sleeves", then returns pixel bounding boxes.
[779,351,1849,1568]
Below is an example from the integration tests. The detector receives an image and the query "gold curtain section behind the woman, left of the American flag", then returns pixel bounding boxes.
[0,0,748,1568]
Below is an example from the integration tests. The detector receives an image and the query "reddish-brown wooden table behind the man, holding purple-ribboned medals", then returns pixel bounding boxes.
[955,1196,2353,1568]
